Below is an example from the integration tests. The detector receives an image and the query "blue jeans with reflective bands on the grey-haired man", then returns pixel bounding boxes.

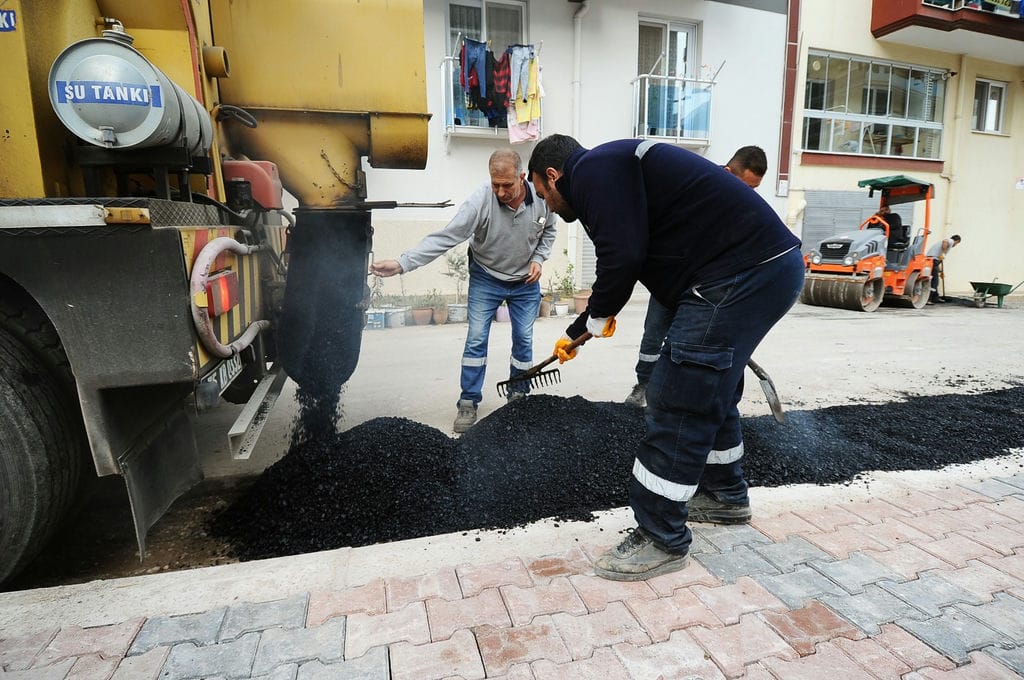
[459,262,541,405]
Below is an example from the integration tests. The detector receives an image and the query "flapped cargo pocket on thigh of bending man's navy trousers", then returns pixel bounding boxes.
[648,342,732,415]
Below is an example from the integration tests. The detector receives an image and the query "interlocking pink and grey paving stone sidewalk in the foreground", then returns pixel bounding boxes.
[0,475,1024,680]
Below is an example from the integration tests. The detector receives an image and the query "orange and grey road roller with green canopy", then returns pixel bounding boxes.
[800,175,933,311]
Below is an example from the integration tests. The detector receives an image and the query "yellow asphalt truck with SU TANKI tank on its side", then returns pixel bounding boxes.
[0,0,429,582]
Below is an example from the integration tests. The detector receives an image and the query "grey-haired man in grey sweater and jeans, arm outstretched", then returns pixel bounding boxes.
[370,150,556,433]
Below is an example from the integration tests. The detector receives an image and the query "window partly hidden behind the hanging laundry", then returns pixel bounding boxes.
[444,0,526,128]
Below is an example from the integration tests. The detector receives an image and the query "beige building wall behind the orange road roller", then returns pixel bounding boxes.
[787,0,1024,294]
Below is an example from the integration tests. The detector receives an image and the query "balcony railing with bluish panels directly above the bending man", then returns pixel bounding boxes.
[632,74,715,146]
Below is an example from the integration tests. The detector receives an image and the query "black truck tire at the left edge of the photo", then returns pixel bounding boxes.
[0,328,81,583]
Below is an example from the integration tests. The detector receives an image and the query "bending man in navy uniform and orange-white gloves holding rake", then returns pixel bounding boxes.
[528,134,804,581]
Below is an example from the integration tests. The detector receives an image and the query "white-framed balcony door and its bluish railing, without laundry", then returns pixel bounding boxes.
[634,18,712,140]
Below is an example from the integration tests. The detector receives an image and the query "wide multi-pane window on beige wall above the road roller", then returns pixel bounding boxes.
[803,50,942,159]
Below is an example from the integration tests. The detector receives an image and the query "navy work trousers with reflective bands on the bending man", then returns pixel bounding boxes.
[629,249,804,553]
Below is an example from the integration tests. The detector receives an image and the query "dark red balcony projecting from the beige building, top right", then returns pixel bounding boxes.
[871,0,1024,66]
